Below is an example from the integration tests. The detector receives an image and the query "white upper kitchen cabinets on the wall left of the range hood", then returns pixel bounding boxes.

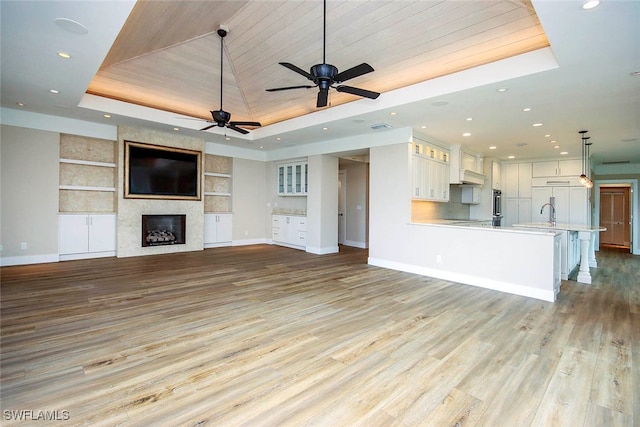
[411,142,449,202]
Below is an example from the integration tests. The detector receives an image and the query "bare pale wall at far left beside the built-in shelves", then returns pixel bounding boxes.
[0,125,60,265]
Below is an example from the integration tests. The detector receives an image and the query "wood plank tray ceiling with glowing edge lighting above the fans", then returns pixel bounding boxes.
[87,0,549,125]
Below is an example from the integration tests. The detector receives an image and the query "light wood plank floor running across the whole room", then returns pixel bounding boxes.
[0,245,640,427]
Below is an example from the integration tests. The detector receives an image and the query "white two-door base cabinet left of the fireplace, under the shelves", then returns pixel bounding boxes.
[58,214,116,260]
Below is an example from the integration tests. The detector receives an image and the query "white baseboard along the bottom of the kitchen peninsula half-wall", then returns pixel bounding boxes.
[368,257,556,302]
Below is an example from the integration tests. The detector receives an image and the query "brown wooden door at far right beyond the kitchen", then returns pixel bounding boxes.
[600,186,631,249]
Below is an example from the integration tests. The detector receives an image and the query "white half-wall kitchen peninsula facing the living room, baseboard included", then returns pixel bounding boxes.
[369,220,561,301]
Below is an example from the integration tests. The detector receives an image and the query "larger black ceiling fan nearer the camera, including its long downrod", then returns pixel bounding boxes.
[267,0,380,108]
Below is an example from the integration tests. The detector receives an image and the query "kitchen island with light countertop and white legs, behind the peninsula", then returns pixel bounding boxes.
[513,222,606,284]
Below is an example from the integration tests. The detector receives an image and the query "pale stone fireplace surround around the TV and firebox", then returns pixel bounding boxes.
[116,126,205,257]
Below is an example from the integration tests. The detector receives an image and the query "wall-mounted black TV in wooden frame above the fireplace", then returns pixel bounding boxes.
[124,141,202,200]
